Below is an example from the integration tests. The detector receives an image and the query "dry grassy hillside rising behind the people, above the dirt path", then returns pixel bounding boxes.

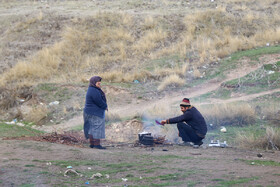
[0,0,280,124]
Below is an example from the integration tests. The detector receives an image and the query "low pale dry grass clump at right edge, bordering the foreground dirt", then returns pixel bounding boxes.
[236,127,280,150]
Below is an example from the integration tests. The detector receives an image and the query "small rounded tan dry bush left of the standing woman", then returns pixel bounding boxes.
[23,105,49,124]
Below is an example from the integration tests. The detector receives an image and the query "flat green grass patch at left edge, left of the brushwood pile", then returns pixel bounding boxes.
[0,122,43,138]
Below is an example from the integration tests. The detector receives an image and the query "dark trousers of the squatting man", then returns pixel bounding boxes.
[177,122,203,143]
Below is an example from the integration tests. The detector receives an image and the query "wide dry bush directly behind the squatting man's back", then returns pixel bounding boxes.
[199,103,256,127]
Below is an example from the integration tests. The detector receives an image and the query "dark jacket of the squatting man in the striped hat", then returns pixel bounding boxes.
[167,107,207,137]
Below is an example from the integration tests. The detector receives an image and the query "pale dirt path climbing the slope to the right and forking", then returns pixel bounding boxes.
[40,54,280,132]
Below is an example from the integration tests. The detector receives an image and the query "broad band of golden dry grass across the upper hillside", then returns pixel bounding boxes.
[0,0,280,86]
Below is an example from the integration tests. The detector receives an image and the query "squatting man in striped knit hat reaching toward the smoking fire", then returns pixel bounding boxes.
[161,98,207,146]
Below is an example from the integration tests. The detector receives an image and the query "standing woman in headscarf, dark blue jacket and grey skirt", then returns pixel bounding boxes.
[84,76,108,149]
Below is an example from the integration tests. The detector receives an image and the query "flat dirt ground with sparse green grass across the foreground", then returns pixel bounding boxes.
[0,140,280,186]
